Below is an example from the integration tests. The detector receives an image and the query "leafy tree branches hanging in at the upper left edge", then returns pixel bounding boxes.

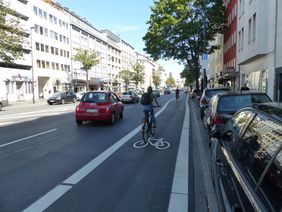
[0,0,25,65]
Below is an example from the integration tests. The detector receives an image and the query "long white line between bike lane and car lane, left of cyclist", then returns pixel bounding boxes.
[24,98,174,212]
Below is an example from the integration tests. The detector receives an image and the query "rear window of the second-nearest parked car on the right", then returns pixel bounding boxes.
[217,94,271,113]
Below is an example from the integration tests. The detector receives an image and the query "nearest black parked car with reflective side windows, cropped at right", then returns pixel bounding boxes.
[211,102,282,211]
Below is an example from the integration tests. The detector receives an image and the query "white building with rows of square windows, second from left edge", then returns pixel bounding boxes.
[31,0,72,98]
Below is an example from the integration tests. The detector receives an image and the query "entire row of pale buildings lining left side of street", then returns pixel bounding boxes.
[0,0,164,102]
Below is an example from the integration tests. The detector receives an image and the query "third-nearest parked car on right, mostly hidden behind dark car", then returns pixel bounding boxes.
[199,88,230,119]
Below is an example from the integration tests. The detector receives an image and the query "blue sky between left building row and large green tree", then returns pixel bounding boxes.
[56,0,183,78]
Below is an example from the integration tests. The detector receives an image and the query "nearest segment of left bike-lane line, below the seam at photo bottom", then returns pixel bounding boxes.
[23,185,71,212]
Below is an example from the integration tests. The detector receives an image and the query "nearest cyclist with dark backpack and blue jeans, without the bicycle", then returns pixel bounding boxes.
[143,86,160,128]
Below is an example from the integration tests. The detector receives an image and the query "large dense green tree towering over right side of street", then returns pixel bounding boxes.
[143,0,225,88]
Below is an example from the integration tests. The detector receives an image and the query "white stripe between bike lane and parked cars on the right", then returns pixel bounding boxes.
[168,96,189,212]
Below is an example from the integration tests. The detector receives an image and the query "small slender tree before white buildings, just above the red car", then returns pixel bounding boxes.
[73,48,99,90]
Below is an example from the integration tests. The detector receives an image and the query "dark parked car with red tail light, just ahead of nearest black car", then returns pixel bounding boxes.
[203,92,271,143]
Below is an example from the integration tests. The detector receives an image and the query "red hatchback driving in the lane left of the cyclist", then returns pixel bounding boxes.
[75,91,124,125]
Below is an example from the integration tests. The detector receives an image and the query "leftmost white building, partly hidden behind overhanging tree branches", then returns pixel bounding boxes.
[0,0,33,102]
